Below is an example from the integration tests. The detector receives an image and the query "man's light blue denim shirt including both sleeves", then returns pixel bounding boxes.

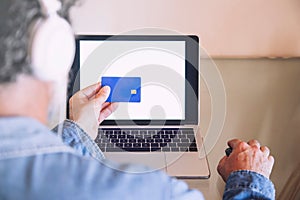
[0,117,274,200]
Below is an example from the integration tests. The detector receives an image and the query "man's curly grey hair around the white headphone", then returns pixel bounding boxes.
[0,0,76,84]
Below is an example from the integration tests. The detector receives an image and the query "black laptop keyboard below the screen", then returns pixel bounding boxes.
[95,128,197,152]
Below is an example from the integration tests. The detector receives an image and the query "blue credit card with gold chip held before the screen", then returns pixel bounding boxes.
[101,77,141,102]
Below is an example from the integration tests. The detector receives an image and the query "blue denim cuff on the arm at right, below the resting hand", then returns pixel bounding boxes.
[223,170,275,200]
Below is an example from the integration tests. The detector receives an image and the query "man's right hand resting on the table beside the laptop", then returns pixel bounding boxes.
[217,139,274,182]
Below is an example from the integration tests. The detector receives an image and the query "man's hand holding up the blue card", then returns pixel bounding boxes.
[69,83,117,139]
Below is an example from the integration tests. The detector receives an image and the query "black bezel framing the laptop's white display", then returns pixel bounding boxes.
[67,35,199,125]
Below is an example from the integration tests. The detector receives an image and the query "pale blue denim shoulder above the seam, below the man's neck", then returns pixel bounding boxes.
[0,117,74,159]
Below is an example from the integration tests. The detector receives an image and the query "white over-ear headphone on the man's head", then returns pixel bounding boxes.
[28,0,75,81]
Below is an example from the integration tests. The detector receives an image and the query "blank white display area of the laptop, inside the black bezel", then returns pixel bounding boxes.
[79,40,185,120]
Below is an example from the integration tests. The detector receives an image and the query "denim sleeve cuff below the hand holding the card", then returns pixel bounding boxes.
[52,119,105,161]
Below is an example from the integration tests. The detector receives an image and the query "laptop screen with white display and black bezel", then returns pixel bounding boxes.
[69,36,198,124]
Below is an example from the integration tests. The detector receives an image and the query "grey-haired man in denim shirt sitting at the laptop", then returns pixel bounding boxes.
[0,0,274,199]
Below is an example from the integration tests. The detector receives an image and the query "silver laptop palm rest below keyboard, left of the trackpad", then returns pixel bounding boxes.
[104,152,166,173]
